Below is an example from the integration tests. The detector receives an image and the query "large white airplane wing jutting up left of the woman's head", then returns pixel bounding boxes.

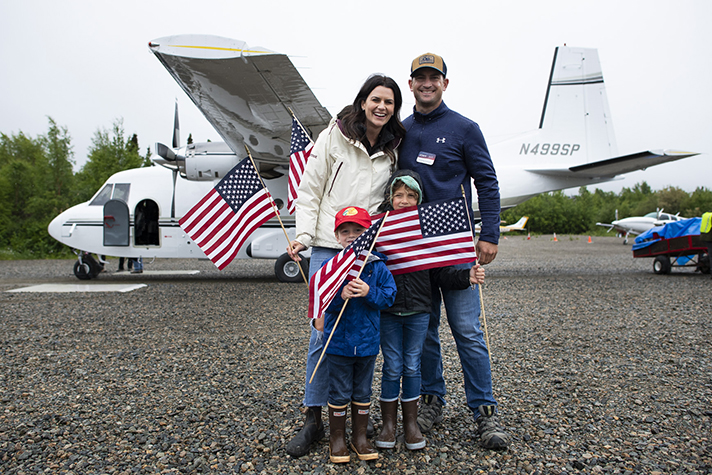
[148,35,331,165]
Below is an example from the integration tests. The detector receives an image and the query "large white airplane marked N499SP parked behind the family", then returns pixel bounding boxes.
[48,35,697,282]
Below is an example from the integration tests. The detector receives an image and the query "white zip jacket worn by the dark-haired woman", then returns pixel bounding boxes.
[295,118,397,249]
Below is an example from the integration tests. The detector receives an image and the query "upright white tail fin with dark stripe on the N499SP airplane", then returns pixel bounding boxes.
[538,46,617,164]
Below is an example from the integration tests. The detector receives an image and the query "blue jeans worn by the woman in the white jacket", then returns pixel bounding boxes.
[303,247,340,407]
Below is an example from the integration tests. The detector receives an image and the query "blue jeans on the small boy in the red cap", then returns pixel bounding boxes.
[324,355,376,406]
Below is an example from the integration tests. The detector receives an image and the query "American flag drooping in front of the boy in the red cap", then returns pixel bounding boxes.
[309,218,383,318]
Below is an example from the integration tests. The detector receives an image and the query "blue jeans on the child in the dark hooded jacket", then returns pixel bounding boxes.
[381,312,430,402]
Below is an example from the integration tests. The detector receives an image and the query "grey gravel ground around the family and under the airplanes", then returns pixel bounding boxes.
[0,236,712,474]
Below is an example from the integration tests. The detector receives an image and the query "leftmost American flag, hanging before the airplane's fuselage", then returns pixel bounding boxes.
[178,157,274,270]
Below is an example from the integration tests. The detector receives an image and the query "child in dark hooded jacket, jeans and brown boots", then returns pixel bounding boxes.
[376,170,484,450]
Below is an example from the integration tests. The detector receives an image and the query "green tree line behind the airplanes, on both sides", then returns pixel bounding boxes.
[0,117,712,259]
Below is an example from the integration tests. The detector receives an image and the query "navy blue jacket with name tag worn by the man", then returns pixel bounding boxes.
[398,102,500,244]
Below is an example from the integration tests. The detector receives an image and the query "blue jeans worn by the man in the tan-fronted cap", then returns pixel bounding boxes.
[420,264,497,418]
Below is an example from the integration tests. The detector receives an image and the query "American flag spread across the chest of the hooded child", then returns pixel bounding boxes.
[376,198,477,275]
